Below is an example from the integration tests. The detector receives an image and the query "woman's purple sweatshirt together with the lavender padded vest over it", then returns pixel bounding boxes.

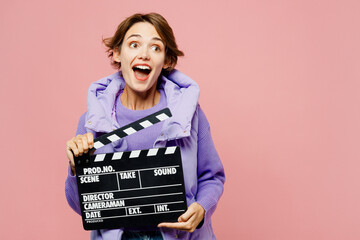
[65,70,225,240]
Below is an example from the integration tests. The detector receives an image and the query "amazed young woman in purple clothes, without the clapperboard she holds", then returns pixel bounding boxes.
[65,13,225,240]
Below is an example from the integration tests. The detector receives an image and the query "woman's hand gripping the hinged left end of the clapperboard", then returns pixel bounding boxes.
[66,133,94,175]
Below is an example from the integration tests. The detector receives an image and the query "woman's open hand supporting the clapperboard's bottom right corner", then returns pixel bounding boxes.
[158,202,205,232]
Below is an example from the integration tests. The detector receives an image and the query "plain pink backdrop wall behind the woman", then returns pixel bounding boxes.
[0,0,360,240]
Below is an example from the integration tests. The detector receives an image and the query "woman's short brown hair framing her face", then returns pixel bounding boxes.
[103,13,184,71]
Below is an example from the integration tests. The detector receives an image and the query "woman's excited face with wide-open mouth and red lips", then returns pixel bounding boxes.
[114,22,167,93]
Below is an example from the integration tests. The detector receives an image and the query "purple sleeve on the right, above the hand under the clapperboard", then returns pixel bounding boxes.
[196,107,225,228]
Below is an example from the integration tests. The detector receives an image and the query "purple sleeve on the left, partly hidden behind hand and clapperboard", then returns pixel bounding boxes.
[65,113,86,214]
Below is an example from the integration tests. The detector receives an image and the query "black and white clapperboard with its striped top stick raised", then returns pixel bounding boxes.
[75,108,187,230]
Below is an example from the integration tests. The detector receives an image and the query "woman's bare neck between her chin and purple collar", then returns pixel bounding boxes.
[120,84,160,110]
